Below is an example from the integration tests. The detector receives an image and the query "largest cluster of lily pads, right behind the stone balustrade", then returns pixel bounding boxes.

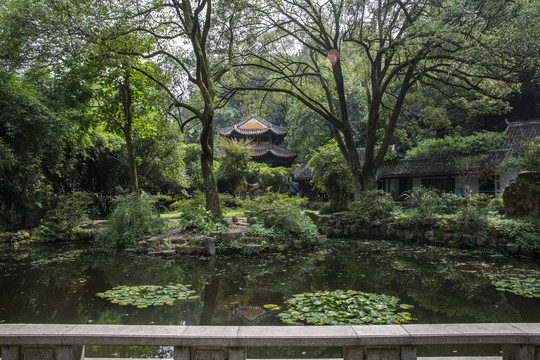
[278,290,412,325]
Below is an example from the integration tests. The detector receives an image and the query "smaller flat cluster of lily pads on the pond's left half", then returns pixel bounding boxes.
[96,284,199,309]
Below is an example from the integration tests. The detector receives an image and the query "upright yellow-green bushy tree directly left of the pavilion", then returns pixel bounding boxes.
[216,138,251,193]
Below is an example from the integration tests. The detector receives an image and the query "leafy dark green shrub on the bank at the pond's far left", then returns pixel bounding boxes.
[41,191,92,238]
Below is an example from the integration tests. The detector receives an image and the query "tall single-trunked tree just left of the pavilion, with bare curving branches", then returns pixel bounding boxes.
[110,0,254,218]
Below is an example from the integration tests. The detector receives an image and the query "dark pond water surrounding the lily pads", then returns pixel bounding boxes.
[0,240,540,357]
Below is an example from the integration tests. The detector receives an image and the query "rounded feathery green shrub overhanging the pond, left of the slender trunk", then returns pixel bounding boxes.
[96,193,163,249]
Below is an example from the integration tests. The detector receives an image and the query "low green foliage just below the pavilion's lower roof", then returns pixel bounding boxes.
[247,162,292,192]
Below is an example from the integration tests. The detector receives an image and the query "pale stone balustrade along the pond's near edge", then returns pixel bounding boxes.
[0,323,540,360]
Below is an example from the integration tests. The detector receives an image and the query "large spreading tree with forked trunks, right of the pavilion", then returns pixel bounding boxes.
[232,0,538,198]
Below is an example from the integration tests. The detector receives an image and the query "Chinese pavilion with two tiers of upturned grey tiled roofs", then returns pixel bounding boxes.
[219,115,297,167]
